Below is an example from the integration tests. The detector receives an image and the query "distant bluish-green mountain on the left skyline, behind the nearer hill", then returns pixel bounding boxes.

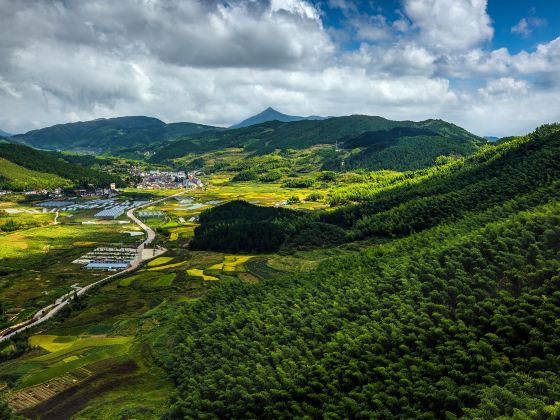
[11,116,219,154]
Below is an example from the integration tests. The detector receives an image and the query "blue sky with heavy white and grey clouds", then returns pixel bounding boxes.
[0,0,560,136]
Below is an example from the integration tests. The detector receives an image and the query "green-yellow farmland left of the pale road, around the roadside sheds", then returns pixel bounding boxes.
[0,224,138,326]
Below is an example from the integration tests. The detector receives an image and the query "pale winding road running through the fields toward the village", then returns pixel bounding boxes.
[0,192,183,343]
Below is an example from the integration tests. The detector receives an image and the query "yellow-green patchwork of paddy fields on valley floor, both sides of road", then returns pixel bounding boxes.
[0,180,350,419]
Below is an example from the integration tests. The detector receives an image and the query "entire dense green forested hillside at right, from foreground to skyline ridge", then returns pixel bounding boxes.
[162,126,560,419]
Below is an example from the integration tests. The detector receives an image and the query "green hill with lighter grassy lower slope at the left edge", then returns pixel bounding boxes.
[0,143,121,190]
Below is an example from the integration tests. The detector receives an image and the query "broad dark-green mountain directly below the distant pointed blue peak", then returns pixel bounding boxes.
[151,115,486,170]
